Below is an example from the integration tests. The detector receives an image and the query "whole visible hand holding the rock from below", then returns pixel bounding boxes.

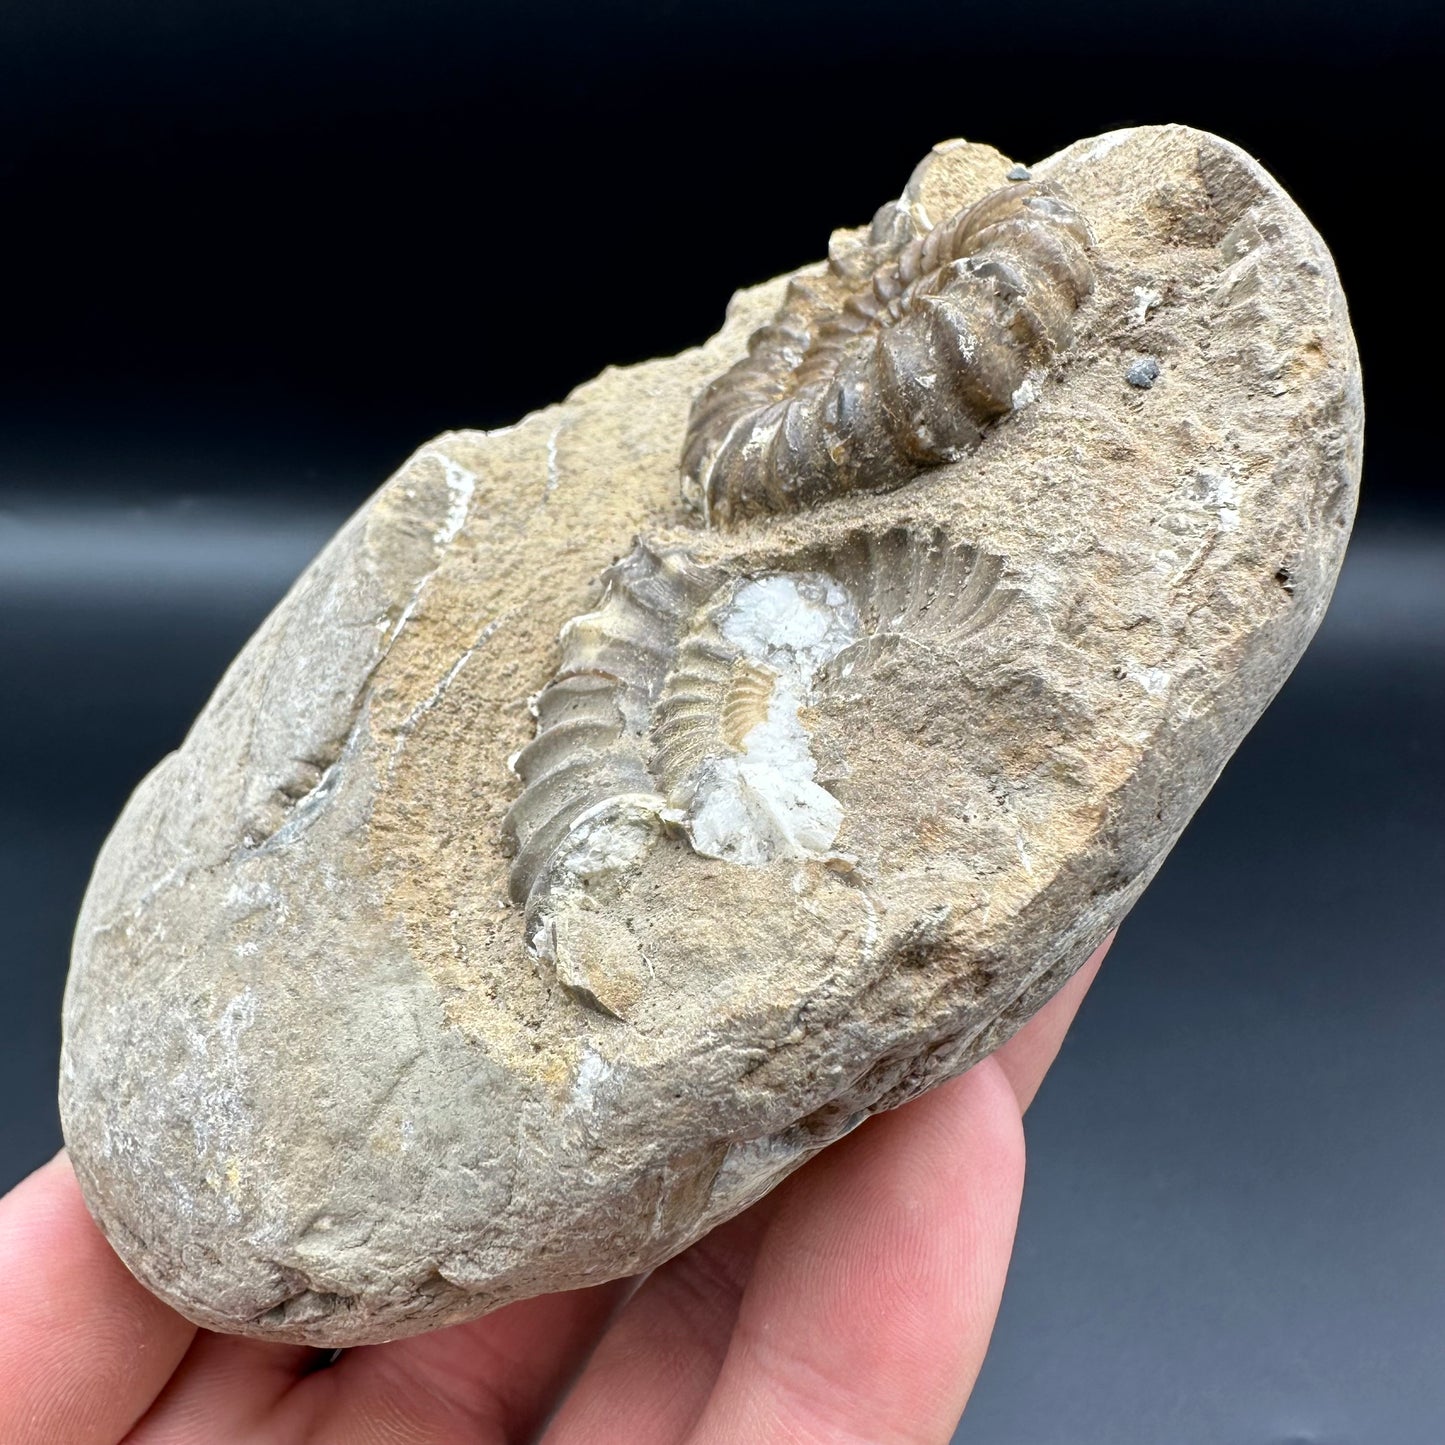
[0,942,1108,1445]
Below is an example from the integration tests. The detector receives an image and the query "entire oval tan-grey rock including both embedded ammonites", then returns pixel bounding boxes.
[61,127,1363,1345]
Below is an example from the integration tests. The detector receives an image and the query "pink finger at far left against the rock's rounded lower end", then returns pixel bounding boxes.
[0,1155,195,1445]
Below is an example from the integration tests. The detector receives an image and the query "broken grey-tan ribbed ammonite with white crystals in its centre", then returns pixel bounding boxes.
[506,526,1010,1005]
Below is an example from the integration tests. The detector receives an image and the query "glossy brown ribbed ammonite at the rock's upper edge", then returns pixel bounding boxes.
[682,182,1094,525]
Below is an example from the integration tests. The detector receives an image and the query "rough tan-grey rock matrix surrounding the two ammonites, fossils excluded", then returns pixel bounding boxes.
[61,127,1363,1345]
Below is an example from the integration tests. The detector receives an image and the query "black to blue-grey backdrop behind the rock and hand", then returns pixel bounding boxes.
[0,0,1445,1445]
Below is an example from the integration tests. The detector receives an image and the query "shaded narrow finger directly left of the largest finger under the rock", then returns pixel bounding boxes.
[546,1195,779,1445]
